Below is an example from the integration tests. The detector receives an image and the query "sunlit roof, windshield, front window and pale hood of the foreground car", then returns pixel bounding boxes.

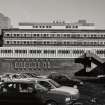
[21,78,80,100]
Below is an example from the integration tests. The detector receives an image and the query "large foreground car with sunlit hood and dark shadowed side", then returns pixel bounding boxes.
[0,79,79,105]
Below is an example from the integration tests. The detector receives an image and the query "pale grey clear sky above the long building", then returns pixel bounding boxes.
[0,0,105,28]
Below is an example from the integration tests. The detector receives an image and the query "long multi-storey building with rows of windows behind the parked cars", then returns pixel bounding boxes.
[0,20,105,71]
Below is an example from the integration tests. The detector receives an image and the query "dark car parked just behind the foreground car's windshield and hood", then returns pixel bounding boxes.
[38,73,83,87]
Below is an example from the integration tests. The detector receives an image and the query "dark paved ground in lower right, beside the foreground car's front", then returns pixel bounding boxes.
[79,82,105,105]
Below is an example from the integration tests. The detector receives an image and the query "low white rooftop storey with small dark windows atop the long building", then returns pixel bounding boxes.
[19,20,95,30]
